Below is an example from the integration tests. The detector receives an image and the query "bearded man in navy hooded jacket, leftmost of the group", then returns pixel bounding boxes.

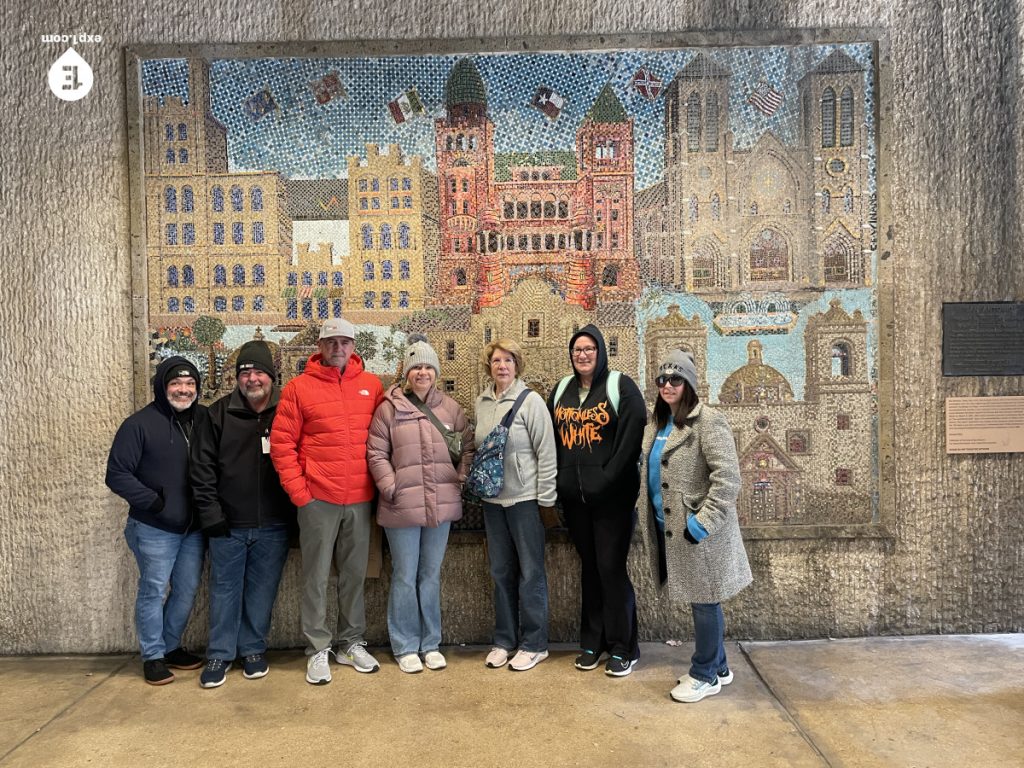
[106,356,205,685]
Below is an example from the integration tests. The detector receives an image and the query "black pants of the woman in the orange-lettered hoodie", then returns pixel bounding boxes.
[563,503,640,659]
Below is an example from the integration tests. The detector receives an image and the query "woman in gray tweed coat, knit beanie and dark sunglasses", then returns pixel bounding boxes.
[641,349,752,702]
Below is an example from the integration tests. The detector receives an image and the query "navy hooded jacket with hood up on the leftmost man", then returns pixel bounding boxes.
[106,356,206,534]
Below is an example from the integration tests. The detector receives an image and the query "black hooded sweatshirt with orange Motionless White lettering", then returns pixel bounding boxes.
[548,325,647,514]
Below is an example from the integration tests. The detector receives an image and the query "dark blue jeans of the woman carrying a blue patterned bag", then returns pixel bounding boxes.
[483,500,548,653]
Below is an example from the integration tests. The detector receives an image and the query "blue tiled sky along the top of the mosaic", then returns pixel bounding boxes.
[142,43,874,189]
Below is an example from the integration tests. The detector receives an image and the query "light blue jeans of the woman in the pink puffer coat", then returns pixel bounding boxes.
[384,522,452,656]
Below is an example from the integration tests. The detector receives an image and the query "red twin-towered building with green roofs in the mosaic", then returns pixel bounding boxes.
[428,58,640,312]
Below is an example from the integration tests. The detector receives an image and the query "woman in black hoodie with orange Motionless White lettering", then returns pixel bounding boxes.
[548,325,647,677]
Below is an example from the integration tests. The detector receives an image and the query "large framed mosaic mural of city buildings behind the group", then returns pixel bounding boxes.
[125,28,894,539]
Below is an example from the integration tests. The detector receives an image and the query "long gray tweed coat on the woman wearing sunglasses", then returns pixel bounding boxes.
[639,402,753,603]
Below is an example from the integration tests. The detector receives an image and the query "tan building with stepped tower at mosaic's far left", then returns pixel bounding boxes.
[142,59,292,327]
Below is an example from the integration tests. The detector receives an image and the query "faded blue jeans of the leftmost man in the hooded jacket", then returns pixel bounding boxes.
[125,517,206,662]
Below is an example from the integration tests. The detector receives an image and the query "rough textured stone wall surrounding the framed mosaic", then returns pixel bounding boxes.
[0,0,1024,653]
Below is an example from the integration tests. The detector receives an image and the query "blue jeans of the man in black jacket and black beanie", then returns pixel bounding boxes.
[206,525,288,662]
